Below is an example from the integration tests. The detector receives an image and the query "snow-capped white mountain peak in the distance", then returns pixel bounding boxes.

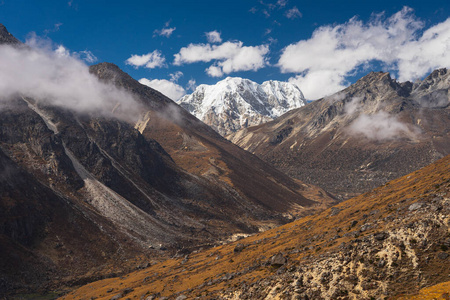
[177,77,306,136]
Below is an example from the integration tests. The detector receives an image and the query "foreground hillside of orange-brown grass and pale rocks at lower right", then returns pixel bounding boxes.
[61,156,450,300]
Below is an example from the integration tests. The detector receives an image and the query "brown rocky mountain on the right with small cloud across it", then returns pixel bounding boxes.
[228,69,450,198]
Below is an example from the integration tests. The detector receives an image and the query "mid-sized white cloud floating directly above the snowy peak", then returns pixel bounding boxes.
[174,41,269,77]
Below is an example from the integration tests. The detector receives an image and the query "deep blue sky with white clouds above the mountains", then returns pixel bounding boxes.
[0,0,450,99]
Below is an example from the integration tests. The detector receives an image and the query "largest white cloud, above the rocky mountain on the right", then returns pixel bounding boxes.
[278,7,450,99]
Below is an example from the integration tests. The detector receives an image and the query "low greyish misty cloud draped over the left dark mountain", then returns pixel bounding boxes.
[0,40,141,121]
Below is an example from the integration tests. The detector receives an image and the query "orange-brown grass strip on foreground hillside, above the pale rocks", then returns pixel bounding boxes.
[61,156,450,299]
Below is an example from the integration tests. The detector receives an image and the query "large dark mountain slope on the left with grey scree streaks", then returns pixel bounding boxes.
[0,25,334,295]
